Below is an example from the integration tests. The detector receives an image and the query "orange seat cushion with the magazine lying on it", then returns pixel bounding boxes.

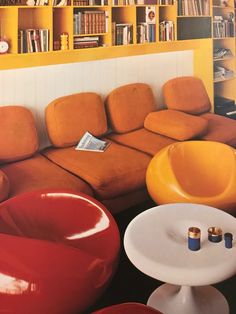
[43,142,151,199]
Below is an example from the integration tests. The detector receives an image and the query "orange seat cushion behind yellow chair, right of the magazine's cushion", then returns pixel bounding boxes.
[109,128,175,156]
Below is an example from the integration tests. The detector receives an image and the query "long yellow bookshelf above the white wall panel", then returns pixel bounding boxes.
[0,0,213,109]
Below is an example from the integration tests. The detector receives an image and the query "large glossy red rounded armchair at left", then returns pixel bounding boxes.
[0,191,120,314]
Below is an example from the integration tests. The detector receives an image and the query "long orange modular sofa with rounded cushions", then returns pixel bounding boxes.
[0,77,236,214]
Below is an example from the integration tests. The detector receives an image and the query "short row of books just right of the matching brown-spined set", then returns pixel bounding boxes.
[112,22,133,46]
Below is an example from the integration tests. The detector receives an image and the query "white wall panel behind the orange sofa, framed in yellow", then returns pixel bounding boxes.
[0,51,193,147]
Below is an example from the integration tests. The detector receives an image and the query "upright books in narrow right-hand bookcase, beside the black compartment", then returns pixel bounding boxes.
[213,16,234,38]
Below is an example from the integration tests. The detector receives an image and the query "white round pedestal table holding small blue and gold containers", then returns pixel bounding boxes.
[124,203,236,314]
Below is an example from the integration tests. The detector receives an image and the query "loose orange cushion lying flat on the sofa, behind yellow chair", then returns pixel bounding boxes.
[144,109,208,141]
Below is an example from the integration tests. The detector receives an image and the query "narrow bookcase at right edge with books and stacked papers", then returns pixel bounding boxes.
[212,0,236,109]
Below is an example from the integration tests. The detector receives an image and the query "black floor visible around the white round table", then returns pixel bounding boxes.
[84,201,236,314]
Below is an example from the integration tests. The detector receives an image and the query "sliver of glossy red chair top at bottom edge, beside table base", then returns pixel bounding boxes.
[93,302,162,314]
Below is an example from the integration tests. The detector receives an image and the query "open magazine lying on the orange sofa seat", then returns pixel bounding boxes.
[75,132,110,153]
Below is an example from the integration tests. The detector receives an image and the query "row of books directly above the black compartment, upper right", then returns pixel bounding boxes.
[178,0,210,16]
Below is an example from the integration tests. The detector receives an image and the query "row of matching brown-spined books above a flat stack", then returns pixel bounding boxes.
[73,10,108,35]
